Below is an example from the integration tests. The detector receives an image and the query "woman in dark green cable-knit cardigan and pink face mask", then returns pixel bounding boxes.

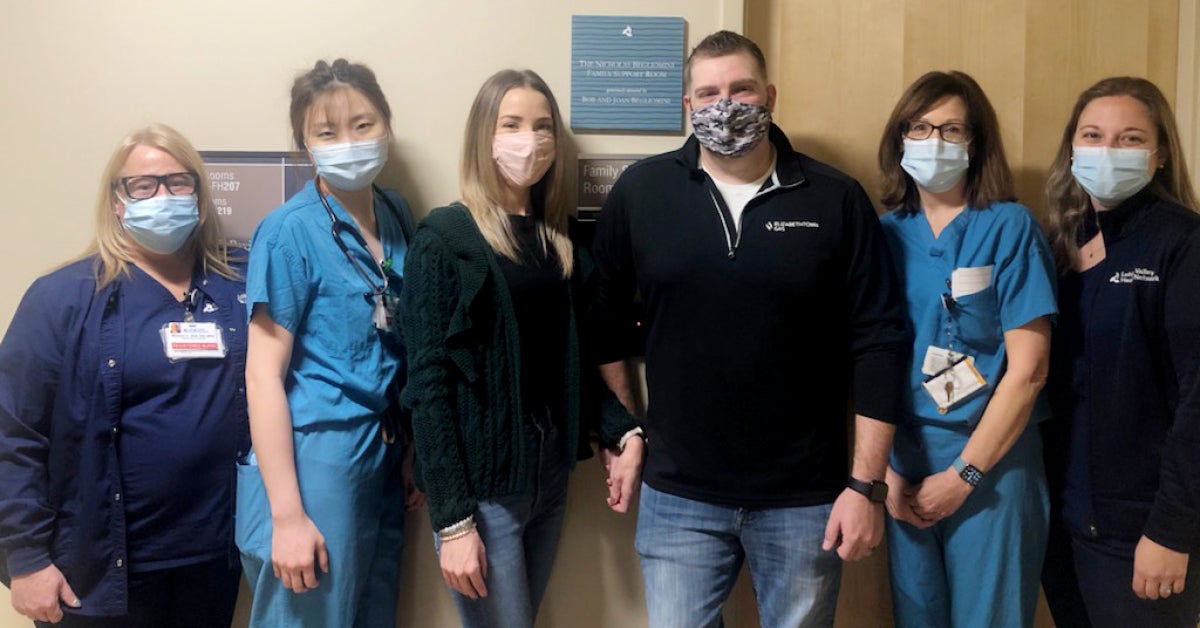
[403,70,642,628]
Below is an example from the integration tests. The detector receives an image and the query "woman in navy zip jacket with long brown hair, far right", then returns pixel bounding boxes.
[1046,77,1200,628]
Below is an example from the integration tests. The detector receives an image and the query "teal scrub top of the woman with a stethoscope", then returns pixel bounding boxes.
[246,181,408,430]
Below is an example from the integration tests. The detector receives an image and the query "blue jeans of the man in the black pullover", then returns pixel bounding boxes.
[636,484,841,628]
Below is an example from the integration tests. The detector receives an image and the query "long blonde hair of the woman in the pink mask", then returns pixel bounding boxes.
[460,70,574,277]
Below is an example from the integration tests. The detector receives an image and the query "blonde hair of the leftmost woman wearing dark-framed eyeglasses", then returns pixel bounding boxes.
[82,124,238,291]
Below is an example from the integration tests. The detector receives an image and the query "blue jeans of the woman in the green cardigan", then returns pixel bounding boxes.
[433,420,575,628]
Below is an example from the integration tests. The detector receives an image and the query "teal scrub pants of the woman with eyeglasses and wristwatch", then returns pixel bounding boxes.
[887,425,1050,628]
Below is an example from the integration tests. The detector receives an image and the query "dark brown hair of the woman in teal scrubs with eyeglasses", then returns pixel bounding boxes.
[880,71,1016,211]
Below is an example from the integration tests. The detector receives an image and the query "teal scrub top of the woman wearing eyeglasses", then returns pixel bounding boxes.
[881,203,1057,430]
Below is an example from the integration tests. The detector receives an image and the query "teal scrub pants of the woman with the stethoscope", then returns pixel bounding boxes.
[236,419,404,628]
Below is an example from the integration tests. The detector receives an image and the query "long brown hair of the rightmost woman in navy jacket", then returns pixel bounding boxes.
[1046,77,1200,273]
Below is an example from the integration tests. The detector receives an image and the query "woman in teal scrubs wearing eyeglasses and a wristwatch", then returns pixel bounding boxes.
[880,72,1057,628]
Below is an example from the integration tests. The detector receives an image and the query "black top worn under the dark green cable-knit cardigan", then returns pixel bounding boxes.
[496,215,570,419]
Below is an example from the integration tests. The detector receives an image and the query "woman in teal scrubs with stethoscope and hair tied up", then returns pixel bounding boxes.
[238,59,421,627]
